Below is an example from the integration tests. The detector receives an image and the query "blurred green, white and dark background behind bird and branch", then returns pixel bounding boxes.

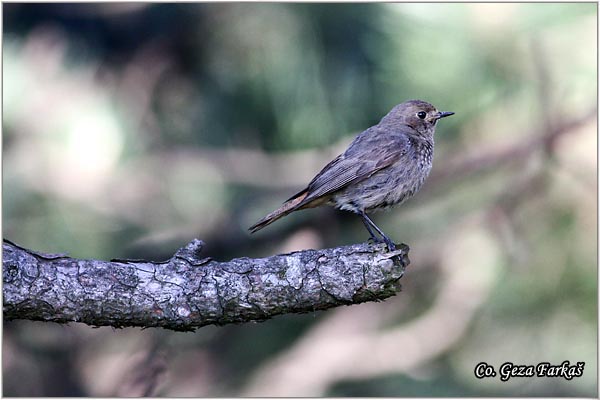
[2,3,598,397]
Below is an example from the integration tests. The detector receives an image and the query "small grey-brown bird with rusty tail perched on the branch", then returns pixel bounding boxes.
[249,100,454,251]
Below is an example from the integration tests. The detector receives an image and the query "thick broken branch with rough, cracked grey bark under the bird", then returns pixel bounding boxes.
[3,239,409,331]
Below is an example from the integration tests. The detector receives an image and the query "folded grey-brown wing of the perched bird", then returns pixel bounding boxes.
[302,131,407,204]
